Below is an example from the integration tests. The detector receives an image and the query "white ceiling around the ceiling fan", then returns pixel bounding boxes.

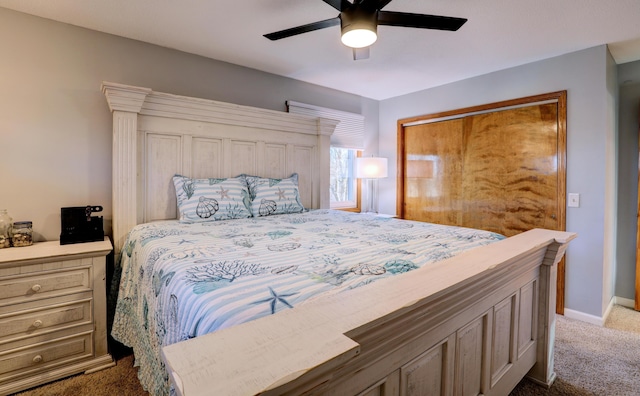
[0,0,640,100]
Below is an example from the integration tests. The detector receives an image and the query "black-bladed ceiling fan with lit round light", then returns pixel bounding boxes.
[264,0,467,60]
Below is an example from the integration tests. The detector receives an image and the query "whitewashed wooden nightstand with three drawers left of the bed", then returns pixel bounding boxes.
[0,237,115,394]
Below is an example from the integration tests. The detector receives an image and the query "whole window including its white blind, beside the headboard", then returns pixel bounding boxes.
[287,100,364,212]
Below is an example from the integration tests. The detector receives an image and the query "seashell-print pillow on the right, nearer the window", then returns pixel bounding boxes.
[240,173,305,217]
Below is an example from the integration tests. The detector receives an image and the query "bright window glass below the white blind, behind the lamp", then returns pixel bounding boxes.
[330,147,360,212]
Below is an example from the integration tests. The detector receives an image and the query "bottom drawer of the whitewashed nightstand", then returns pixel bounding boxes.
[0,332,93,376]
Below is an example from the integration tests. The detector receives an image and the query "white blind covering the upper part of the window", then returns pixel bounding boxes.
[287,100,364,150]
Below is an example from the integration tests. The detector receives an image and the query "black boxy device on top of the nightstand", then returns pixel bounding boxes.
[60,206,104,245]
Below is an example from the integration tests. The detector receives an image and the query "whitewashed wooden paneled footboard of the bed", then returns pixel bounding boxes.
[163,229,576,396]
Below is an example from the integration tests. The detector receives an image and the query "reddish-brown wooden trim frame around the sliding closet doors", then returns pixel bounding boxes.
[396,91,568,314]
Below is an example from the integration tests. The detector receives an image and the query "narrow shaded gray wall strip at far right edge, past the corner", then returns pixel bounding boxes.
[615,61,640,300]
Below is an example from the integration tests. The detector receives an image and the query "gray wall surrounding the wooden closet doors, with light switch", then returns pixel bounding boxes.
[379,46,615,317]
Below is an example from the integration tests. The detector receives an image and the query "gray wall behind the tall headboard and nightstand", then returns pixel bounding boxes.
[0,8,378,240]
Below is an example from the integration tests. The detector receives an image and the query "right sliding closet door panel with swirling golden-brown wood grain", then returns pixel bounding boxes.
[463,103,558,236]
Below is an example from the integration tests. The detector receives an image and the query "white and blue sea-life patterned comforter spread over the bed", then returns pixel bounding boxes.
[112,210,504,395]
